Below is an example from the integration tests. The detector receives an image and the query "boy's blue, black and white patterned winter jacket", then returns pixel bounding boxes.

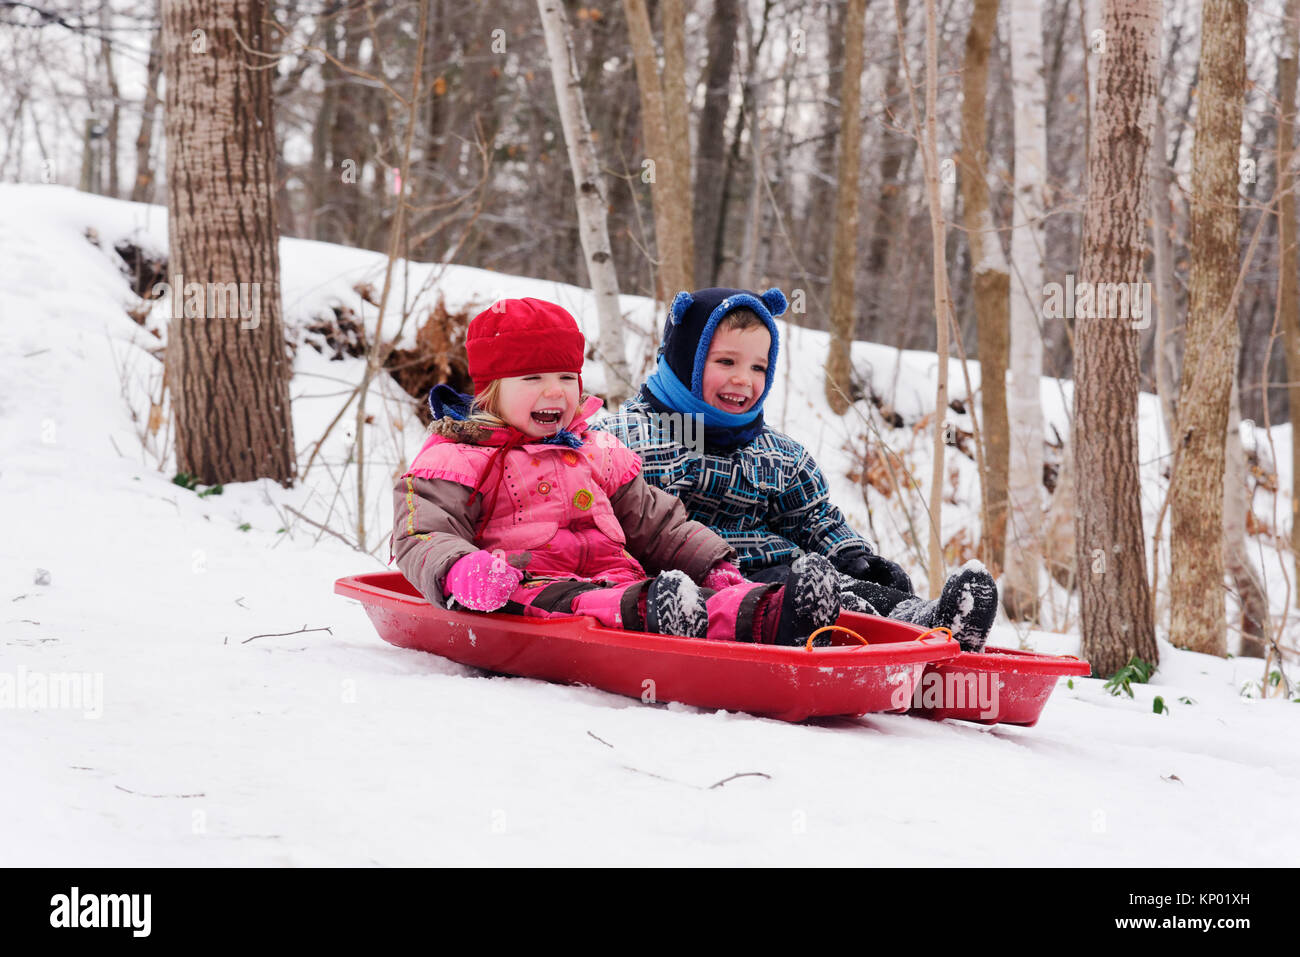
[592,398,871,573]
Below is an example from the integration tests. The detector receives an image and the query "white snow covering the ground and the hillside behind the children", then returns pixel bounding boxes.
[0,186,1300,866]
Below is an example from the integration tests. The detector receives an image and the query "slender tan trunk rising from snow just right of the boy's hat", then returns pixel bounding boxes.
[826,0,867,415]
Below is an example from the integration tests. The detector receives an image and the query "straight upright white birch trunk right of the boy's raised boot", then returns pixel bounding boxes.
[993,0,1048,620]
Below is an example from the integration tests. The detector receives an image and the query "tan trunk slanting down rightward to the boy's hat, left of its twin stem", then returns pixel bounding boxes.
[623,0,686,299]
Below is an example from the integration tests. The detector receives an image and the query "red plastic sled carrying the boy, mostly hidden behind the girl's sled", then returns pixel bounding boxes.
[907,648,1092,726]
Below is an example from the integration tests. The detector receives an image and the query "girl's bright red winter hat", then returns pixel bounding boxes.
[465,299,586,394]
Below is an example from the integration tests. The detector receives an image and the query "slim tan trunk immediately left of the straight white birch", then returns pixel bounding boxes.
[962,0,1011,575]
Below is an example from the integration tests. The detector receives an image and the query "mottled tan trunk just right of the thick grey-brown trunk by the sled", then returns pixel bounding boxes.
[1169,0,1245,655]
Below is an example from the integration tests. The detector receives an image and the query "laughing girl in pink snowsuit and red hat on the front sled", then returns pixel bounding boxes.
[393,299,840,644]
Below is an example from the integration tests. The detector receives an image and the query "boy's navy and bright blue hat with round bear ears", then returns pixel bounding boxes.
[659,286,787,407]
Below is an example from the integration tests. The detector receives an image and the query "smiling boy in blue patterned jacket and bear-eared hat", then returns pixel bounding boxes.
[593,289,997,651]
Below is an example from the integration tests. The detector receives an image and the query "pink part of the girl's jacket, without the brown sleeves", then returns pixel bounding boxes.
[404,397,676,583]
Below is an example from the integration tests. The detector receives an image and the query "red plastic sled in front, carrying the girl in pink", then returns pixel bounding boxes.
[334,572,961,722]
